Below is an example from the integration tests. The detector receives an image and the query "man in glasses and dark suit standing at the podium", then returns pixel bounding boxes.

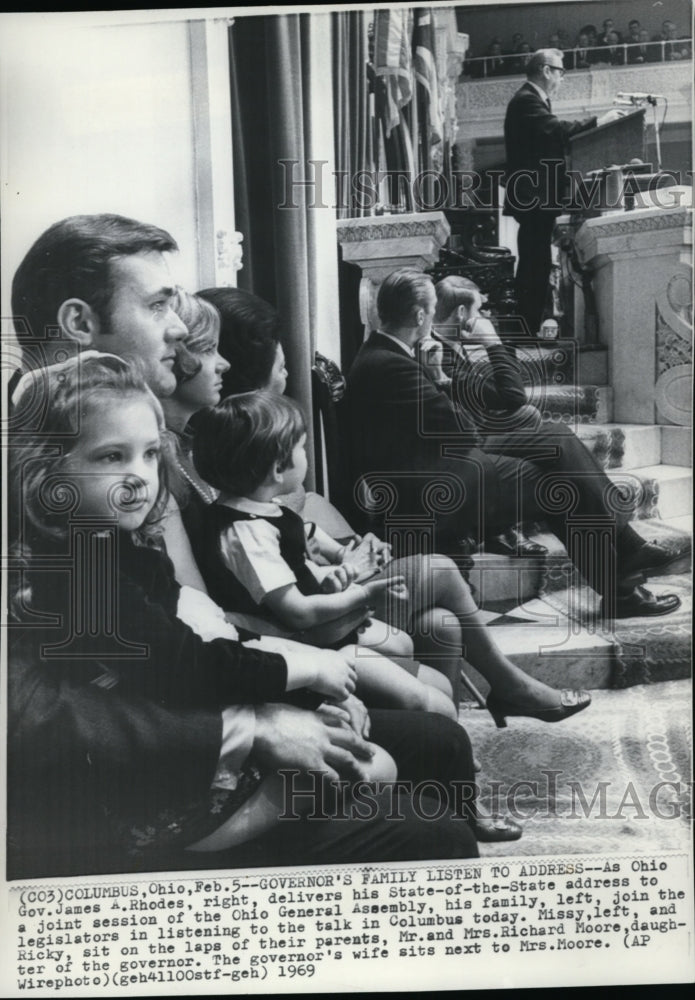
[504,49,622,337]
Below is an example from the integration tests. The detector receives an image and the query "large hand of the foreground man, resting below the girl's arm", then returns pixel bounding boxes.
[253,705,373,781]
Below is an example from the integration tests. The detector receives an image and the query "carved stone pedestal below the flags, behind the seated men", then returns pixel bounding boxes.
[338,212,451,333]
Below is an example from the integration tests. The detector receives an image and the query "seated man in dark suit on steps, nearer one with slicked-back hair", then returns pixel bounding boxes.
[345,268,680,617]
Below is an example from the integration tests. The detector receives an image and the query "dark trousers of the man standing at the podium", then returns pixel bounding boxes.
[514,210,555,337]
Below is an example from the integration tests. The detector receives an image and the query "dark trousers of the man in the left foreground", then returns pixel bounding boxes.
[164,710,478,870]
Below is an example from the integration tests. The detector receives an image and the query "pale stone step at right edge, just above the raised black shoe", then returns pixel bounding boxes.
[609,465,693,519]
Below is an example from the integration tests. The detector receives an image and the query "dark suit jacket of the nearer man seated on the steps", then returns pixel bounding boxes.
[344,333,495,539]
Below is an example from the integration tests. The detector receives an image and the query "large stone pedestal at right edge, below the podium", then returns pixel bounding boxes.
[576,208,692,425]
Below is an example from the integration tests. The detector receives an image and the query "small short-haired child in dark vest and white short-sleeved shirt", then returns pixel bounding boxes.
[193,392,456,718]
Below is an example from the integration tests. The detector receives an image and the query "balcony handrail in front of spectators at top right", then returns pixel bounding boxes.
[461,38,692,79]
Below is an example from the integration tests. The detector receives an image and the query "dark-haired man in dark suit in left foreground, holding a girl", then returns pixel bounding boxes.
[8,215,477,878]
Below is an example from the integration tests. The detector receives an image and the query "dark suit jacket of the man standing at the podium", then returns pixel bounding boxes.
[504,82,596,221]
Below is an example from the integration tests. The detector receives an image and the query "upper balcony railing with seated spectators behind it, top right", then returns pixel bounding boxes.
[461,38,692,80]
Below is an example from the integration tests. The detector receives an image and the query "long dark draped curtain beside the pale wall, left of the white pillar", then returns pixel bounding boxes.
[229,14,321,489]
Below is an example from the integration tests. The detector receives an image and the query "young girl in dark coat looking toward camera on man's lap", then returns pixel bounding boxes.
[11,351,395,857]
